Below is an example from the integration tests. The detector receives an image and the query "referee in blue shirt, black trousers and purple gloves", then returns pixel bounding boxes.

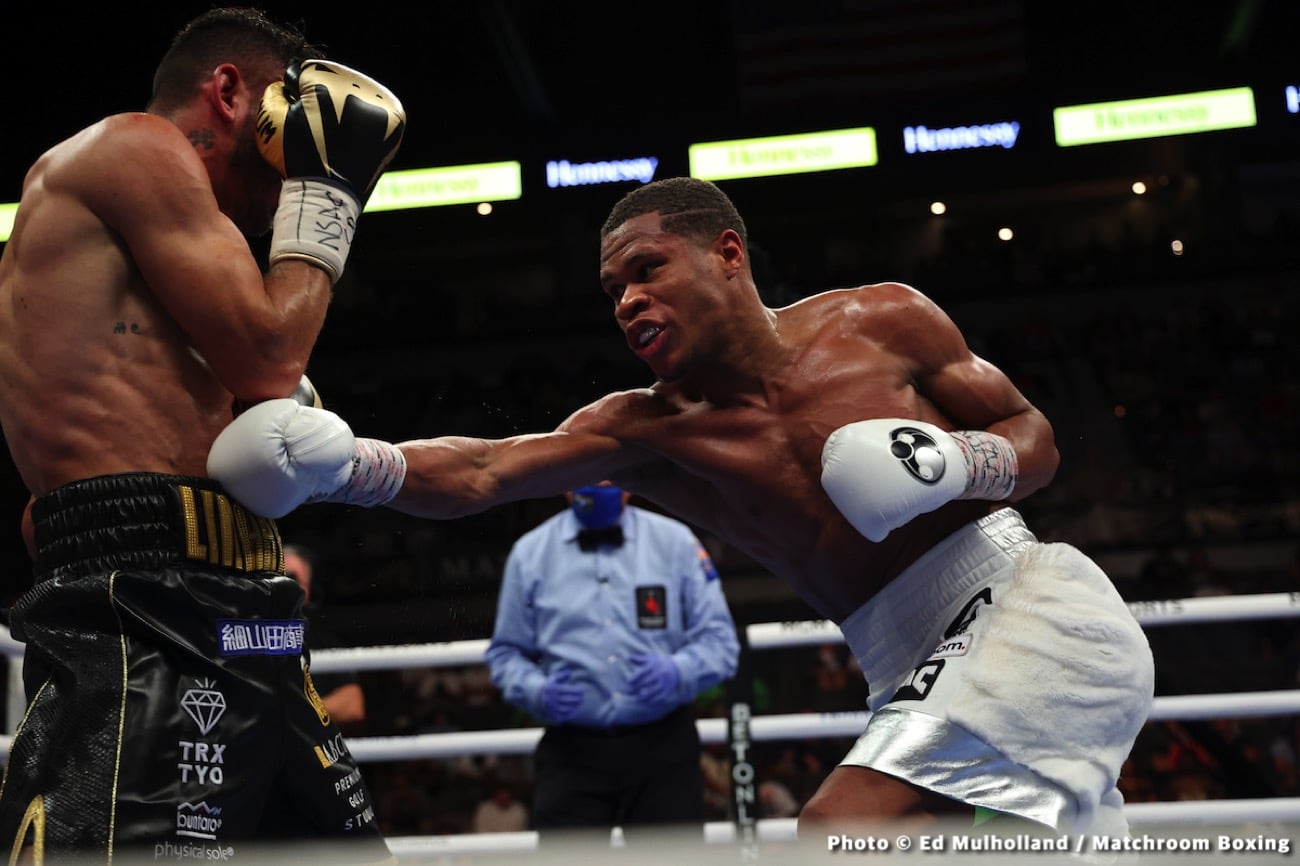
[486,482,740,845]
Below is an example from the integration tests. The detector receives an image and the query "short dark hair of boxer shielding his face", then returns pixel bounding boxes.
[150,7,325,109]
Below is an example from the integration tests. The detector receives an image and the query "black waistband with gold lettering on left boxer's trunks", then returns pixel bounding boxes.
[31,472,285,581]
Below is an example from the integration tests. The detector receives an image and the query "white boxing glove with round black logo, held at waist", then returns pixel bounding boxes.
[822,417,1018,541]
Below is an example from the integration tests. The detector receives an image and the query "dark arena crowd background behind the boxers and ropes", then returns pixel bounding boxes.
[0,0,1300,835]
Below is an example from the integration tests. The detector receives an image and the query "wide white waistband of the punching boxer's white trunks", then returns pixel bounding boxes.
[840,508,1037,701]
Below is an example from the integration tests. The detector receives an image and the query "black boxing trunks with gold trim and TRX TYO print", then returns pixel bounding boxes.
[0,473,391,863]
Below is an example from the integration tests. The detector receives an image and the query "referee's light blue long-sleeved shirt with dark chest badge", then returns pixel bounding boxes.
[486,506,740,727]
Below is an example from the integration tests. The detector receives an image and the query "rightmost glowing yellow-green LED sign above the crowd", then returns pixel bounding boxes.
[1052,87,1256,147]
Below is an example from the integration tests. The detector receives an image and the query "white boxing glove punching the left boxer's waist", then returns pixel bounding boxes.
[208,398,406,518]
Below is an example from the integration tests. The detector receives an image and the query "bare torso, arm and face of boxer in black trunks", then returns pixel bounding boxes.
[0,107,328,495]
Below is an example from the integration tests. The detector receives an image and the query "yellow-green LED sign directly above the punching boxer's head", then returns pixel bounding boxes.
[689,126,878,181]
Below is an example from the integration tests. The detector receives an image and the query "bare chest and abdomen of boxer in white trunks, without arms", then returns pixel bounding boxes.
[571,287,991,622]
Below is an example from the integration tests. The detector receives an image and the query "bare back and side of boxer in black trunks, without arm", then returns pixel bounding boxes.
[0,121,230,495]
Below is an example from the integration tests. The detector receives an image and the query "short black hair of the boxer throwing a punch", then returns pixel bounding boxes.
[601,177,749,248]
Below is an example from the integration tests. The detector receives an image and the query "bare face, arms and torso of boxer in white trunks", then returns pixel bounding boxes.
[390,213,1057,622]
